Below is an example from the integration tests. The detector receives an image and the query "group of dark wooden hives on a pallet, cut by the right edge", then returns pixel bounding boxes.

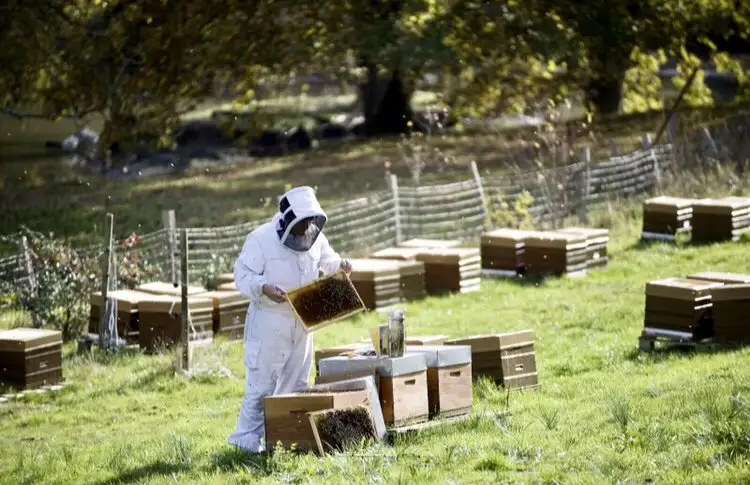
[643,271,750,343]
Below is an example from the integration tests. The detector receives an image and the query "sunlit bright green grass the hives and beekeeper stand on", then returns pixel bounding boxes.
[0,213,750,485]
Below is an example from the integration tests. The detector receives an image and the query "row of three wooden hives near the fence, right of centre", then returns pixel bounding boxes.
[479,227,609,276]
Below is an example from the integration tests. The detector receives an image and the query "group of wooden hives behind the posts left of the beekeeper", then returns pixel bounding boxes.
[84,274,250,352]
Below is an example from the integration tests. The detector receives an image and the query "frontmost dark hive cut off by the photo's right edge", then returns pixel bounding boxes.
[711,283,750,344]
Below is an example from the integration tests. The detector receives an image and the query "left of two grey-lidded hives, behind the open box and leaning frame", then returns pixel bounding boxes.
[320,354,429,427]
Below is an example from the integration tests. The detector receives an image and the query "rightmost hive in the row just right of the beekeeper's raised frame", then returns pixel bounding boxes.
[417,248,482,295]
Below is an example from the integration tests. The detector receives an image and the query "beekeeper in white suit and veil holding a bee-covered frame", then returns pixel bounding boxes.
[229,183,351,453]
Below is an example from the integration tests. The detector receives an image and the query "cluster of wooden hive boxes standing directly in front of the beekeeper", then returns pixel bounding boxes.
[264,330,538,451]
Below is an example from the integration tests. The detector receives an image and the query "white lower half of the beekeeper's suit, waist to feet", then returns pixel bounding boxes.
[229,302,313,453]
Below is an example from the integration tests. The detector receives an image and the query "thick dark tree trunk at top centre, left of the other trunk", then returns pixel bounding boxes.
[361,65,412,136]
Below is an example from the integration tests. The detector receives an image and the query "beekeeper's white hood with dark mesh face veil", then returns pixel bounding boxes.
[274,186,328,251]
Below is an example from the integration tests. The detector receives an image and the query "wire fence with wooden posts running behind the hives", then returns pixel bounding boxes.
[0,109,750,293]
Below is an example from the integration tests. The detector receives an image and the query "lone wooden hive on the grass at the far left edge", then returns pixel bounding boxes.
[0,328,63,389]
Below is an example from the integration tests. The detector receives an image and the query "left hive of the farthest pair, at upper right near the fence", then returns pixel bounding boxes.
[641,196,694,240]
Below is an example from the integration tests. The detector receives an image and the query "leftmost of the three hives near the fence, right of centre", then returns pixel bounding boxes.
[479,228,534,276]
